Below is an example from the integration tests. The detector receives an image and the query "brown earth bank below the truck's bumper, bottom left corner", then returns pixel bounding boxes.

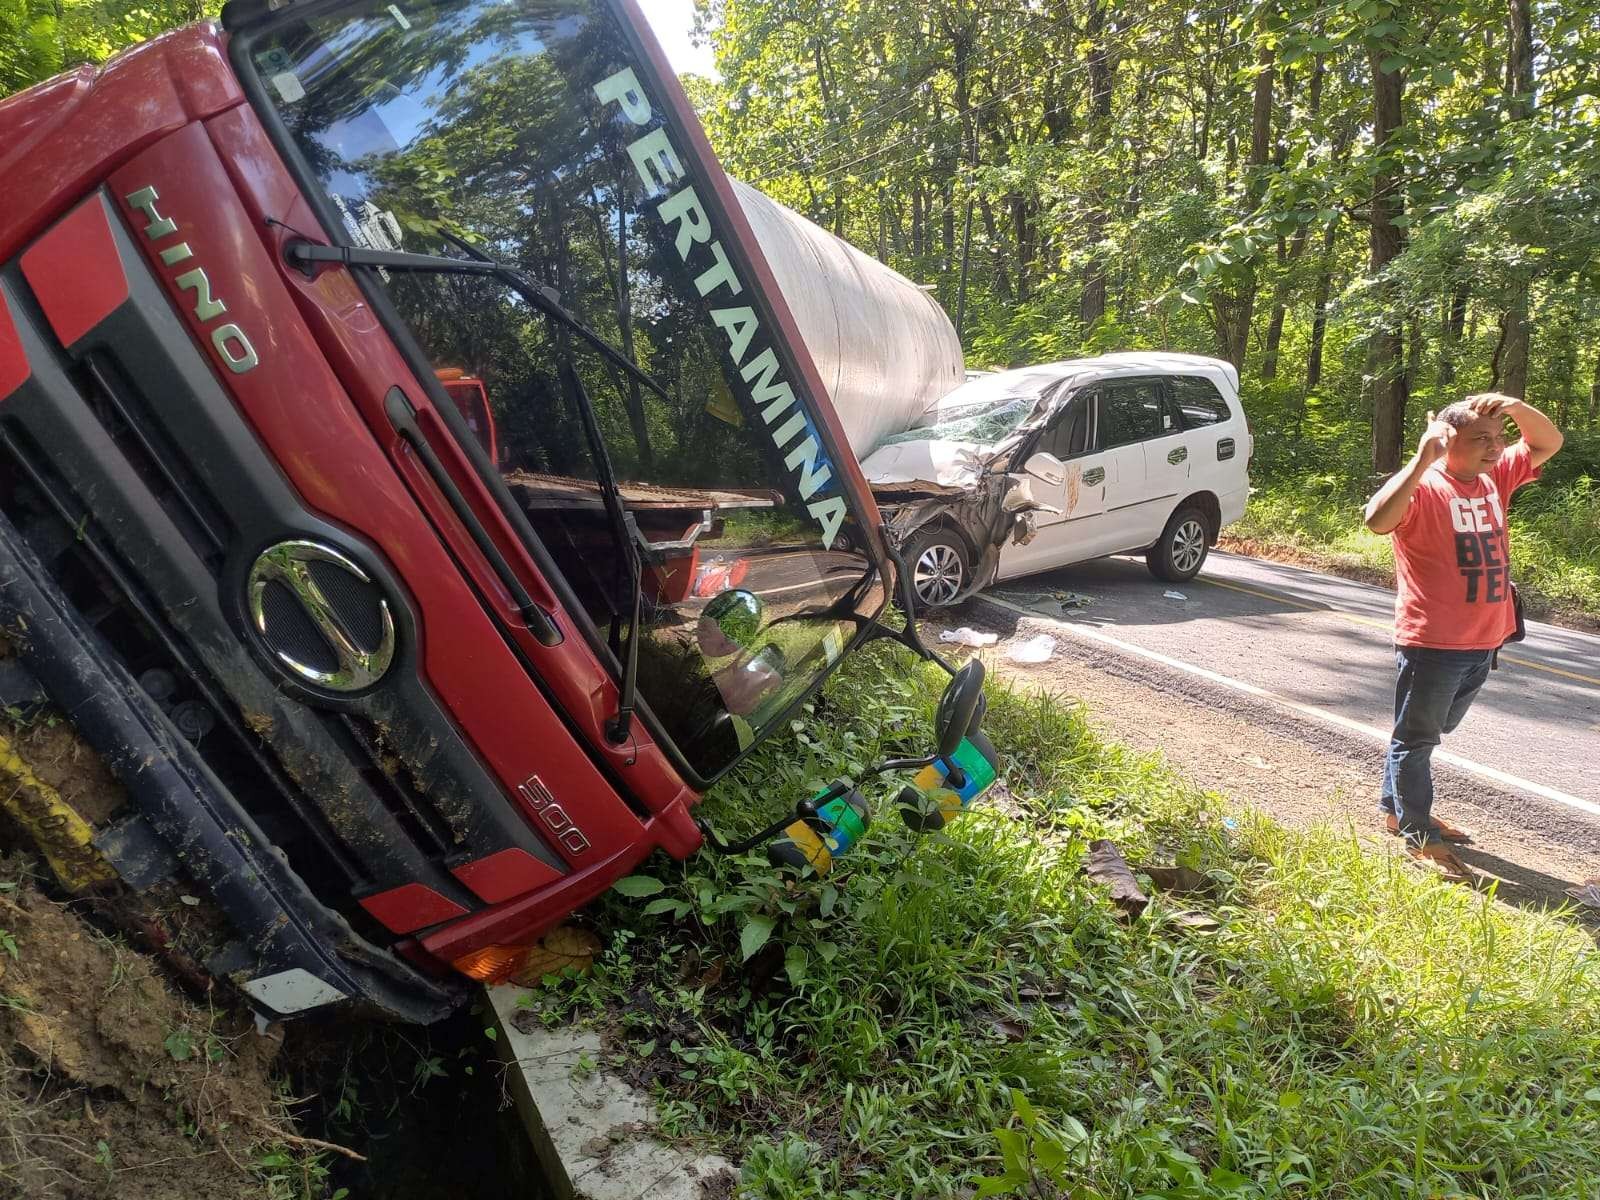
[0,856,300,1200]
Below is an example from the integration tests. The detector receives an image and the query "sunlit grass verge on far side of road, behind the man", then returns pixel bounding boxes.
[1224,475,1600,624]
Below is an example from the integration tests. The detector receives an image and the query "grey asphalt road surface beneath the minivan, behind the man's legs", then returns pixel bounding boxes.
[987,552,1600,819]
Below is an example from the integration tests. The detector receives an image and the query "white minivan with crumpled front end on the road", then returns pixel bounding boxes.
[861,352,1253,608]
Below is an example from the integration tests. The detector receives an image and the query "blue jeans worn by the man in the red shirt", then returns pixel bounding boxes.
[1378,646,1494,843]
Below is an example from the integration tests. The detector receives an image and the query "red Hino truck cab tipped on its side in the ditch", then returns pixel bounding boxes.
[0,0,992,1021]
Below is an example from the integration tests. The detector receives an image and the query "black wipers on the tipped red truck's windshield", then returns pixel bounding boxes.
[283,230,656,746]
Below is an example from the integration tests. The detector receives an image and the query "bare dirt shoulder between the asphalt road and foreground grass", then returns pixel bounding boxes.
[925,602,1600,918]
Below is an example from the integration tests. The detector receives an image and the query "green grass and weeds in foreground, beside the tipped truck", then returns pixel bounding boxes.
[538,648,1600,1200]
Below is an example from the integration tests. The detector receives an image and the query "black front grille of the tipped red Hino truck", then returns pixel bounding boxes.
[0,197,565,941]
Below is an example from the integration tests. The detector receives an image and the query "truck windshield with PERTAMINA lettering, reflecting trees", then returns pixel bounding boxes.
[248,0,885,781]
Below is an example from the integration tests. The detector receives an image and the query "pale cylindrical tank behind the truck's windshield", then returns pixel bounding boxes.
[733,179,966,458]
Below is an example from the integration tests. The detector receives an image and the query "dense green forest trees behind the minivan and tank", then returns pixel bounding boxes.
[693,0,1600,480]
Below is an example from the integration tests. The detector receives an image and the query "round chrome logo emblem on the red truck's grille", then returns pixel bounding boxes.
[248,541,395,691]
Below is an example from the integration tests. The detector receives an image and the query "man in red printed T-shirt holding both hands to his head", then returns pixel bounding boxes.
[1366,392,1562,878]
